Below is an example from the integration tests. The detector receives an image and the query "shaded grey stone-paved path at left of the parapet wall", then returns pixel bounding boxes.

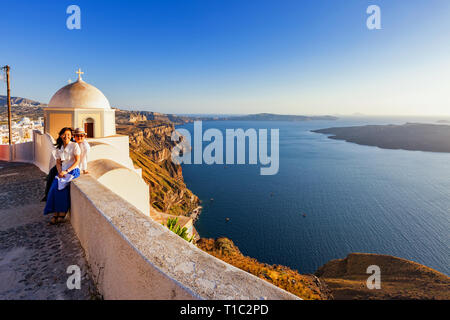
[0,161,98,300]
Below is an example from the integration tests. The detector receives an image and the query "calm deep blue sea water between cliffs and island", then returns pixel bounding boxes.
[178,118,450,275]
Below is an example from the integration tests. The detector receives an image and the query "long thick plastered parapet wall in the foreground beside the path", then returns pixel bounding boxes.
[71,175,298,300]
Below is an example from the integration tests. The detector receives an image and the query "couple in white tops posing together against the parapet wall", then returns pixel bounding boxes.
[42,127,90,224]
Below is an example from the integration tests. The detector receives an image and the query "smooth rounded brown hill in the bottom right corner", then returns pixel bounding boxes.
[316,253,450,300]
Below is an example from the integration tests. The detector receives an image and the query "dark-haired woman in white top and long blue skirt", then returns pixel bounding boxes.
[44,127,81,224]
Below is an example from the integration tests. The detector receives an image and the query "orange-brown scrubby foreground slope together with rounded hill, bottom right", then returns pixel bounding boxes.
[197,238,450,300]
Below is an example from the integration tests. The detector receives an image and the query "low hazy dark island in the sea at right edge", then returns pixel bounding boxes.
[312,123,450,152]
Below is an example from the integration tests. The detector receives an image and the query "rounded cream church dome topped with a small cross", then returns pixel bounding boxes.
[48,71,111,110]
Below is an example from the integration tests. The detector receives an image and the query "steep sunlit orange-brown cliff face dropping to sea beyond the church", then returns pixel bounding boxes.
[117,120,200,216]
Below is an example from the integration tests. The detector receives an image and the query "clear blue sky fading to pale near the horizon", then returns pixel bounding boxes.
[0,0,450,115]
